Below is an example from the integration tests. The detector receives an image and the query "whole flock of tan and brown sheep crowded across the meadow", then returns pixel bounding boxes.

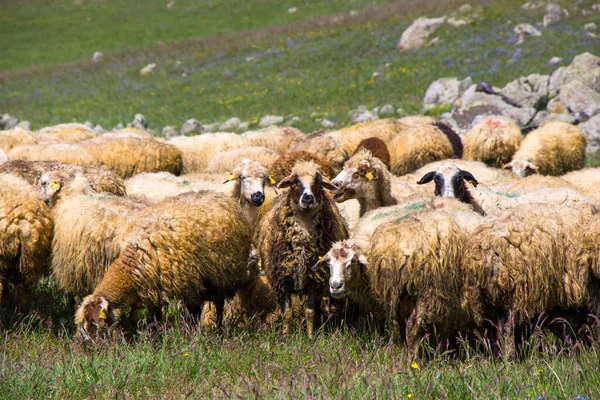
[0,116,600,353]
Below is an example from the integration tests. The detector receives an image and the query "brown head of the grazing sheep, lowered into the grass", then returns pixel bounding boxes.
[75,294,121,340]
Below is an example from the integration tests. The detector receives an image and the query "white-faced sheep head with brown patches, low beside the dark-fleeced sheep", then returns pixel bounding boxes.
[313,240,368,299]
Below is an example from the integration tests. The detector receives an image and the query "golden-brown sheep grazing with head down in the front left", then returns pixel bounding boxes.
[75,192,252,339]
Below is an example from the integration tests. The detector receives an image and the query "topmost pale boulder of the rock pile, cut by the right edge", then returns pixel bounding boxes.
[548,53,600,97]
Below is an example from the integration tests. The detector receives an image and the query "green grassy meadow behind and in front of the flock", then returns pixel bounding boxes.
[0,0,600,399]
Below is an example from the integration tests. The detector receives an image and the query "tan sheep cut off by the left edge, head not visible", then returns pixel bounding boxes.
[0,173,53,306]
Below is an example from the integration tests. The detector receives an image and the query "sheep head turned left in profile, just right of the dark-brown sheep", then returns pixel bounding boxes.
[331,148,385,203]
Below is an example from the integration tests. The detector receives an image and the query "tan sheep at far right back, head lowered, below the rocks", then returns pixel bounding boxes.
[504,121,587,177]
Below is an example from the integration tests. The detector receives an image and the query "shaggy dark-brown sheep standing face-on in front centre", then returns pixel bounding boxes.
[254,161,348,337]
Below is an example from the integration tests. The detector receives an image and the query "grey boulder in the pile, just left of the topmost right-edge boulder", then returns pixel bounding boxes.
[500,74,550,109]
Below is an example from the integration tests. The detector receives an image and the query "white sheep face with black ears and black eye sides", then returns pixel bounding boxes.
[417,163,478,201]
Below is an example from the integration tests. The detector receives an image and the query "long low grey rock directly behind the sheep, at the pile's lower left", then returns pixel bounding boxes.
[452,85,536,129]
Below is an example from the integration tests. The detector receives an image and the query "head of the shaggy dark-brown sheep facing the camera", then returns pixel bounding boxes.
[278,161,336,212]
